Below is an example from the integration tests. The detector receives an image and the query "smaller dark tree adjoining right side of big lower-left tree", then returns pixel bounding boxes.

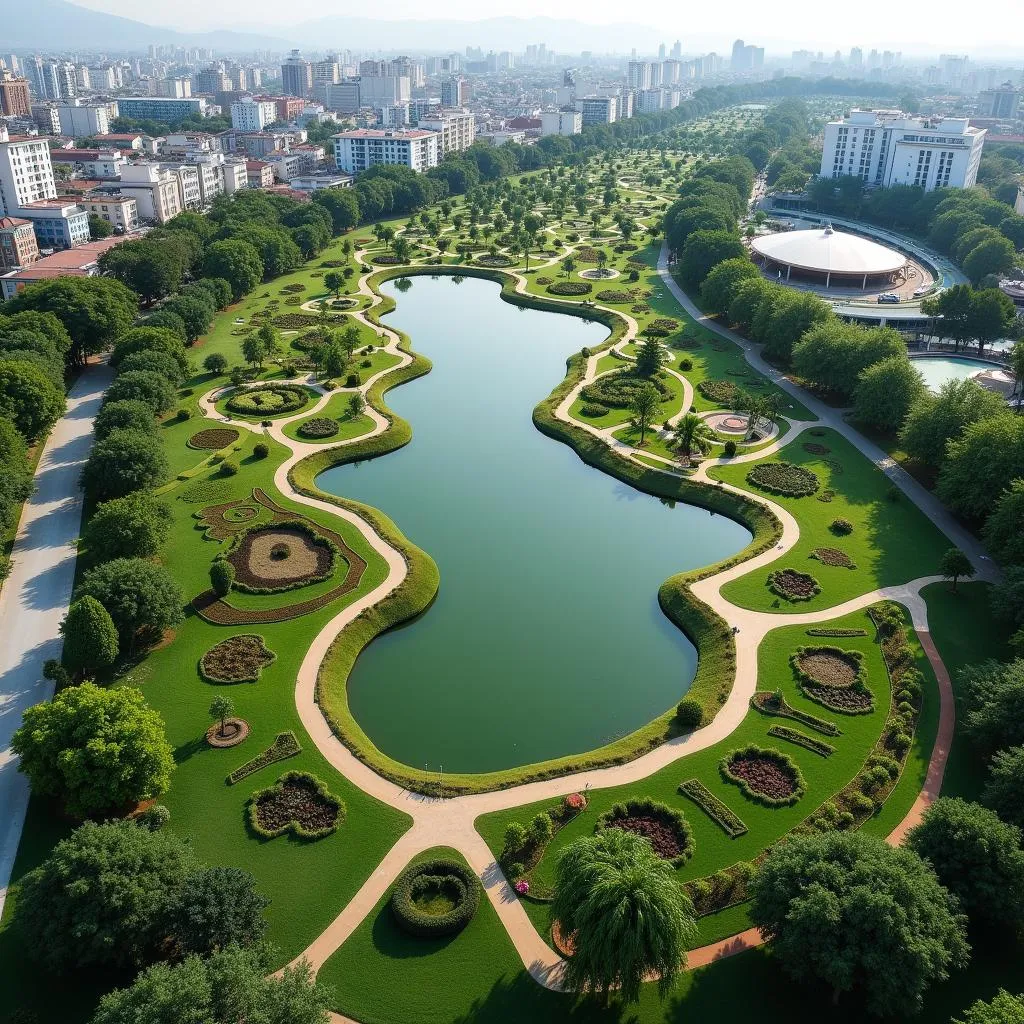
[168,864,270,956]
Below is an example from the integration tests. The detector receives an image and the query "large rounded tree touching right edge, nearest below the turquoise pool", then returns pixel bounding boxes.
[936,411,1024,519]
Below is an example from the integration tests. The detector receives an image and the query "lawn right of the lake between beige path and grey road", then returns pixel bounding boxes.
[709,430,950,612]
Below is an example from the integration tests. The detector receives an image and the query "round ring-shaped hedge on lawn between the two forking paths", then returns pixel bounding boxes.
[391,857,480,939]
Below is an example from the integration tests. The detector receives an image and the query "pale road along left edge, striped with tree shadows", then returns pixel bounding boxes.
[0,365,112,915]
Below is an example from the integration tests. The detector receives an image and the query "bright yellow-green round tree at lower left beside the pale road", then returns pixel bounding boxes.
[11,682,174,817]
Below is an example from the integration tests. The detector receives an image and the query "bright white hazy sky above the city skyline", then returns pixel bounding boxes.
[73,0,1024,56]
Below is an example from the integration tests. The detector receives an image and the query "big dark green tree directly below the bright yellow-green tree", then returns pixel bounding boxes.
[15,819,195,970]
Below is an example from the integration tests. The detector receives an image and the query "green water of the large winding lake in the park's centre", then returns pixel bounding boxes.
[317,276,750,772]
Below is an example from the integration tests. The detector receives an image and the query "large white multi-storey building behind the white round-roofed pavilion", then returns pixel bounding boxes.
[820,111,985,191]
